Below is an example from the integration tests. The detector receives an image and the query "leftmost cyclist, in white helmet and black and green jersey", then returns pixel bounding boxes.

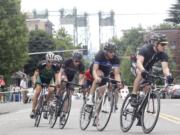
[30,52,59,118]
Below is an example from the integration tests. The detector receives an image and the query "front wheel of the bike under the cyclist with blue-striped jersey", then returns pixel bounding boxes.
[96,91,114,131]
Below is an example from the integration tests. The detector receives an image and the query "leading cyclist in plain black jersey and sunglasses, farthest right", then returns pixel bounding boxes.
[131,33,173,107]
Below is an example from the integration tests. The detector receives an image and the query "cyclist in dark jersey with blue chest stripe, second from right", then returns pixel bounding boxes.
[87,42,122,105]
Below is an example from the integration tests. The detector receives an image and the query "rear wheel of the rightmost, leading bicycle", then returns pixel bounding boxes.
[120,94,135,132]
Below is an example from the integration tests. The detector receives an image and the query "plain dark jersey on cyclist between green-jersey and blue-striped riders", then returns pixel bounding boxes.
[62,58,85,81]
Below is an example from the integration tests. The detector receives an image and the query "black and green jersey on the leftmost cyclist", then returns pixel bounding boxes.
[36,61,59,84]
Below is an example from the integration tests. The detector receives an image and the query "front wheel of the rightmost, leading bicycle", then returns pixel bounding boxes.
[141,92,160,134]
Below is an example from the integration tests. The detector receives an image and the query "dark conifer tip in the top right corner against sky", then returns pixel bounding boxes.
[165,0,180,25]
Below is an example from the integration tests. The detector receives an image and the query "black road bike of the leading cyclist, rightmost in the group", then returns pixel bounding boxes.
[120,74,169,134]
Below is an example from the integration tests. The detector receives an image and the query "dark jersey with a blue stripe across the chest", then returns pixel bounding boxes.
[90,51,120,76]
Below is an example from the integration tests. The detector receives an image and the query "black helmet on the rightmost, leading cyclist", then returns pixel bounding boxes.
[151,33,168,44]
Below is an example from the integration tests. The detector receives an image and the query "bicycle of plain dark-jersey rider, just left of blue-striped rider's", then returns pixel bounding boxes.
[49,81,82,129]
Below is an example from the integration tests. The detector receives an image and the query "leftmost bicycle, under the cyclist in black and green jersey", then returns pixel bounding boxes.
[34,83,48,127]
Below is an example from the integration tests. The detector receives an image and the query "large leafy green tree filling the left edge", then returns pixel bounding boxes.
[0,0,28,81]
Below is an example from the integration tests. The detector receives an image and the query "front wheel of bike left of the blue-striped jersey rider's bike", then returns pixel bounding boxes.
[59,92,71,129]
